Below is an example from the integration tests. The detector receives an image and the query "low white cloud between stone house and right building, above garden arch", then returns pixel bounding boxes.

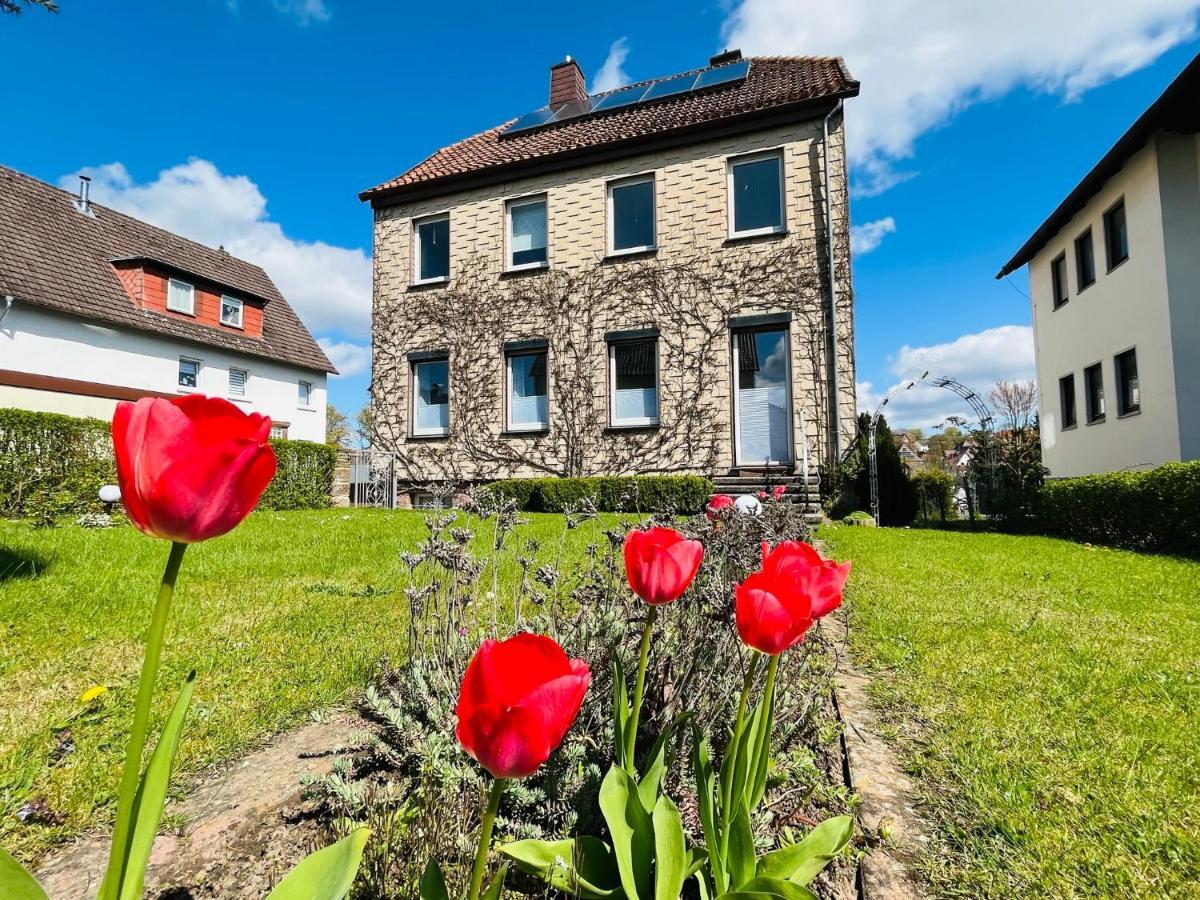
[857,325,1034,428]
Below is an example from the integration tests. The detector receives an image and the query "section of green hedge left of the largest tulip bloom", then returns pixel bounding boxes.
[0,409,116,521]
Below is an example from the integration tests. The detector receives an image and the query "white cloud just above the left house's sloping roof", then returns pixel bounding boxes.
[59,158,371,338]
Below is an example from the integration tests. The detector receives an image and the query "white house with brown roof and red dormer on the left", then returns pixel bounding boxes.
[0,167,336,442]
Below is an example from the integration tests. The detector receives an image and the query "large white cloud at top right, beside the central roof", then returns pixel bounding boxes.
[722,0,1200,193]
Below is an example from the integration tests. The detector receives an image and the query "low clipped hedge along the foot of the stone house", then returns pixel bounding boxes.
[487,475,713,515]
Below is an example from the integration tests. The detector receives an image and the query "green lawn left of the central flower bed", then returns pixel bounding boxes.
[0,510,628,856]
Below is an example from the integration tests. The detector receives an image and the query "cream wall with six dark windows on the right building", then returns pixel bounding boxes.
[1030,142,1180,478]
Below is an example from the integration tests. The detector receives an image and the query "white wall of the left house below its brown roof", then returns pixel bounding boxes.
[0,300,326,442]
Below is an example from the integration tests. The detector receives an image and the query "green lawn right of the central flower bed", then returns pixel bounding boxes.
[822,526,1200,899]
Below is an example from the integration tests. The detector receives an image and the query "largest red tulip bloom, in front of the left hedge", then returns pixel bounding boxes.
[113,394,275,544]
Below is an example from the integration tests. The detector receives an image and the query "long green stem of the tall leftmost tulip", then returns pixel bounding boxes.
[103,541,187,898]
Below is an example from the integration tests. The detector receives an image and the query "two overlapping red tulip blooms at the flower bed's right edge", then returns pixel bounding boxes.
[734,541,850,655]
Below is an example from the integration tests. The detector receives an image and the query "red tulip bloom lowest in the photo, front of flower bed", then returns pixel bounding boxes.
[455,632,592,779]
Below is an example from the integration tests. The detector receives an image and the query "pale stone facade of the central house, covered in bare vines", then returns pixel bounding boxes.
[371,116,856,481]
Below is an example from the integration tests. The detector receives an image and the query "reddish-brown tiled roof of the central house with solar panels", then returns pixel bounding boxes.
[359,56,858,200]
